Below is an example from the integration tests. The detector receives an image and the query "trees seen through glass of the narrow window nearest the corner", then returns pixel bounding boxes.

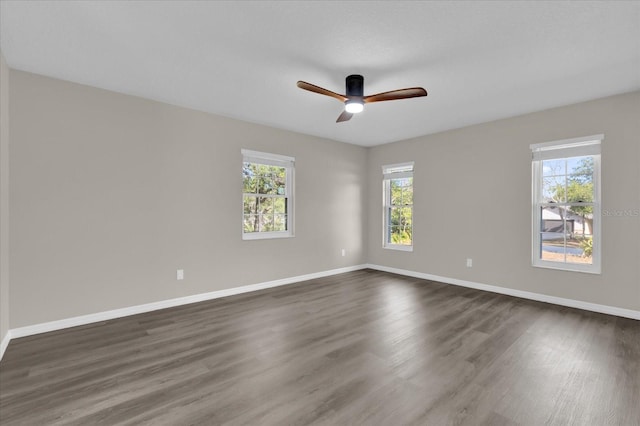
[387,177,413,246]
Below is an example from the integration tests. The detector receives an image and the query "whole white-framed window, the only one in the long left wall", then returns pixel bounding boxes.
[242,149,295,240]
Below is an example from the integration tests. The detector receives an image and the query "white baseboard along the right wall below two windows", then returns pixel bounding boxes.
[365,264,640,320]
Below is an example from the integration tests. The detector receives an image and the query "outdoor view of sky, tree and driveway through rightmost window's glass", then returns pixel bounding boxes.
[540,156,594,264]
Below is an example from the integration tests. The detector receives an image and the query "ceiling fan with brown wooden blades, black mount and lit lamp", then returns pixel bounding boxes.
[297,74,427,123]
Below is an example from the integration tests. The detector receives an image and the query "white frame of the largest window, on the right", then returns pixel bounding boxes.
[530,134,604,274]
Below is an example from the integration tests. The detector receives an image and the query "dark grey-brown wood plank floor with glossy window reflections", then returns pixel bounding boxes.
[0,270,640,425]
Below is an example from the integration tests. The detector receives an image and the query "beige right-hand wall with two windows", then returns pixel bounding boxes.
[368,92,640,310]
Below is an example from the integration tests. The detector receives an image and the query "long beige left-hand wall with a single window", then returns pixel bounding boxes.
[10,70,366,328]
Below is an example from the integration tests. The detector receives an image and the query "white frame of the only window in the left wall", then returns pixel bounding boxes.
[240,149,296,240]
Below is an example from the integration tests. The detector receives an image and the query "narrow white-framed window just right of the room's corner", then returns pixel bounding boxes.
[382,162,413,251]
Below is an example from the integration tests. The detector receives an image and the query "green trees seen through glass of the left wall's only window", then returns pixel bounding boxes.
[242,162,287,233]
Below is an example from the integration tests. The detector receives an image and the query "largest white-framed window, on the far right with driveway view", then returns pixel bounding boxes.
[531,135,603,273]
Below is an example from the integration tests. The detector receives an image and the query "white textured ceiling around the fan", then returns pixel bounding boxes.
[0,0,640,146]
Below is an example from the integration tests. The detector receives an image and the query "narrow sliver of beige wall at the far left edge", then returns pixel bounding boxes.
[0,52,9,341]
